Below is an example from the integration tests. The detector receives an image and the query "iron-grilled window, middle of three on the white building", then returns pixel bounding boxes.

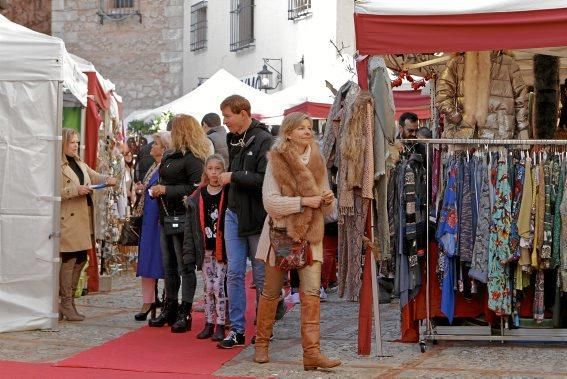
[230,0,254,51]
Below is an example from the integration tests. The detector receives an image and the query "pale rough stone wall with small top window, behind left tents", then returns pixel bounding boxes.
[52,0,183,116]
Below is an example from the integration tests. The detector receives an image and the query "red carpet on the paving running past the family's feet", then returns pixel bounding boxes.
[56,273,255,375]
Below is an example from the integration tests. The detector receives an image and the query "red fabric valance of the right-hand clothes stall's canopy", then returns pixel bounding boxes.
[354,7,567,55]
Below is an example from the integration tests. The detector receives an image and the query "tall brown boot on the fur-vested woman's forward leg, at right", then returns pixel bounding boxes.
[299,292,341,371]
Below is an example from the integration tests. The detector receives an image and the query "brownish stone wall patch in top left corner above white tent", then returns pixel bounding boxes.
[0,0,51,34]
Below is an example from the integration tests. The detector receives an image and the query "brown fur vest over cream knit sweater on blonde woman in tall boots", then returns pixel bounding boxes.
[256,142,336,266]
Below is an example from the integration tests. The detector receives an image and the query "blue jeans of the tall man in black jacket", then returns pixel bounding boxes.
[224,209,264,333]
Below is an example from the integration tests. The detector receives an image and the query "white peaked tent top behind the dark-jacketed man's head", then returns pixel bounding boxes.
[124,69,278,125]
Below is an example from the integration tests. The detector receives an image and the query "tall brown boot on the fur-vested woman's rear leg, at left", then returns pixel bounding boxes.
[254,294,280,363]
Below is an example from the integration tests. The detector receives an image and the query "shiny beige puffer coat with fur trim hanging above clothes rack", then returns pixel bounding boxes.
[436,51,529,139]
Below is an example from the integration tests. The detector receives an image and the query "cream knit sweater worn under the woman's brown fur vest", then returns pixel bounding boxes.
[256,147,337,266]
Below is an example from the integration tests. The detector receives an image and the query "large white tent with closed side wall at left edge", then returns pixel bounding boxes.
[0,16,81,332]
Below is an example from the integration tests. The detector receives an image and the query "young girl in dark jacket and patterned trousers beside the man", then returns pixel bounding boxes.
[183,154,227,341]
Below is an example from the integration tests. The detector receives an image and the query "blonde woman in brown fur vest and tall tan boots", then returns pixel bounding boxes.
[254,112,341,370]
